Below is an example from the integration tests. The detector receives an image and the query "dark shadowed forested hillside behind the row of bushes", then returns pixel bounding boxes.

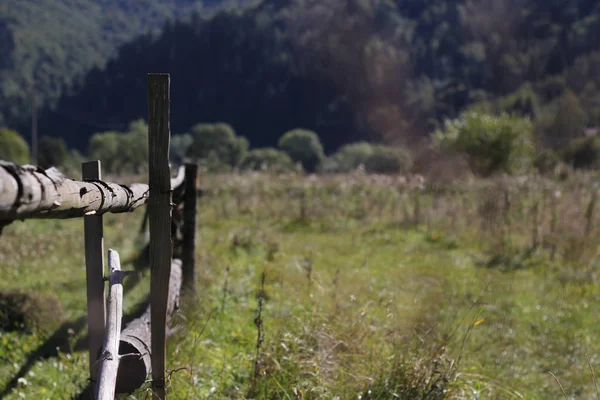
[3,0,600,150]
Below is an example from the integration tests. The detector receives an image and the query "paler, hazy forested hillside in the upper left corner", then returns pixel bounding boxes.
[0,0,253,126]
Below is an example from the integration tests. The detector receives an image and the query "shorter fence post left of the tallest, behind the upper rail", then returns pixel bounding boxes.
[81,161,106,387]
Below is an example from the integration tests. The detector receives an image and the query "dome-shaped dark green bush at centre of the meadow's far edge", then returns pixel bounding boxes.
[279,129,325,172]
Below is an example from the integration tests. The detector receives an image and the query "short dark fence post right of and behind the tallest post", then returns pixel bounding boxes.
[181,164,198,296]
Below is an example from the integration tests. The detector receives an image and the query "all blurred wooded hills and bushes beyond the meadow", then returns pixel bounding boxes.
[0,0,600,174]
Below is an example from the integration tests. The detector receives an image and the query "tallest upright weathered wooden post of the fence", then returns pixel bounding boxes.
[148,74,173,400]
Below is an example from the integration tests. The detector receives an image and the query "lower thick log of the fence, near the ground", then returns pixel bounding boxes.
[116,259,182,393]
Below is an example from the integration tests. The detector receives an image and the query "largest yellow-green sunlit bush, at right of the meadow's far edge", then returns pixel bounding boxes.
[433,112,535,175]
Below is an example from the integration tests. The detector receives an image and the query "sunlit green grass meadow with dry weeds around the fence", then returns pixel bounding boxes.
[0,171,600,399]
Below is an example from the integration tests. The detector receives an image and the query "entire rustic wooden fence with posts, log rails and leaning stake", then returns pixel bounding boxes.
[0,74,198,399]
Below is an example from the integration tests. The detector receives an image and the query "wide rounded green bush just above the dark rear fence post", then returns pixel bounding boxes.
[186,123,249,171]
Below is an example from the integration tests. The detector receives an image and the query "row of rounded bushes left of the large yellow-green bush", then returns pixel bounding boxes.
[0,119,411,174]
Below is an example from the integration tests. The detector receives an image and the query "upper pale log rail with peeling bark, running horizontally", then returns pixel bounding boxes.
[0,161,183,223]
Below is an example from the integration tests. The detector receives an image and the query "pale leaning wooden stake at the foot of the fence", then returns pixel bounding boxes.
[94,249,125,400]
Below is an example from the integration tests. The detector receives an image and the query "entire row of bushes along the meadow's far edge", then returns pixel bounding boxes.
[0,108,600,176]
